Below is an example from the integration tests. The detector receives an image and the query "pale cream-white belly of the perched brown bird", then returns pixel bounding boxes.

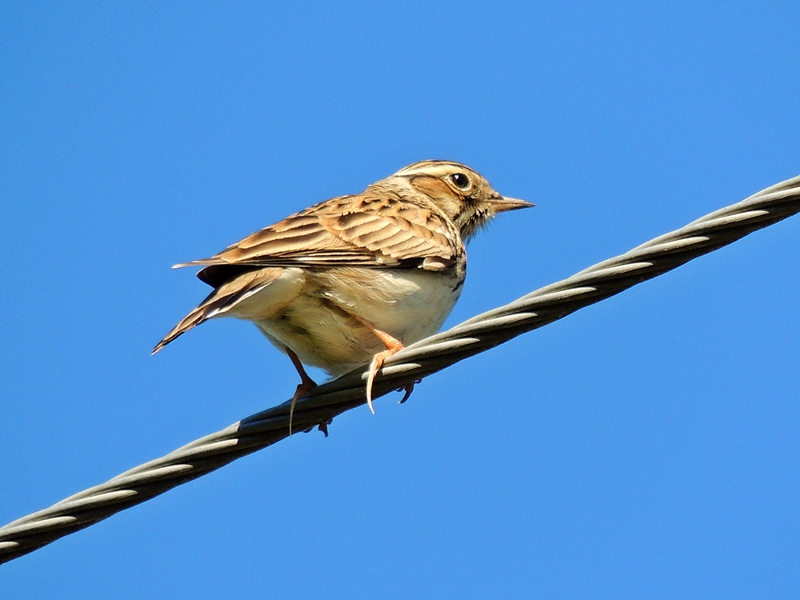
[244,268,461,376]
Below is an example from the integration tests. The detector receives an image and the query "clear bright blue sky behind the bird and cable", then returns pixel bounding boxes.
[0,2,800,598]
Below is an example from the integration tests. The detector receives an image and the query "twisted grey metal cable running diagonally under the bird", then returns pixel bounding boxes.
[0,176,800,563]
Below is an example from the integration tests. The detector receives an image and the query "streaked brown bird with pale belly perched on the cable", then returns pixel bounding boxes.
[152,160,534,435]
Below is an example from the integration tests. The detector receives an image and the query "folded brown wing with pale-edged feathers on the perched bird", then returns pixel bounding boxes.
[175,190,462,286]
